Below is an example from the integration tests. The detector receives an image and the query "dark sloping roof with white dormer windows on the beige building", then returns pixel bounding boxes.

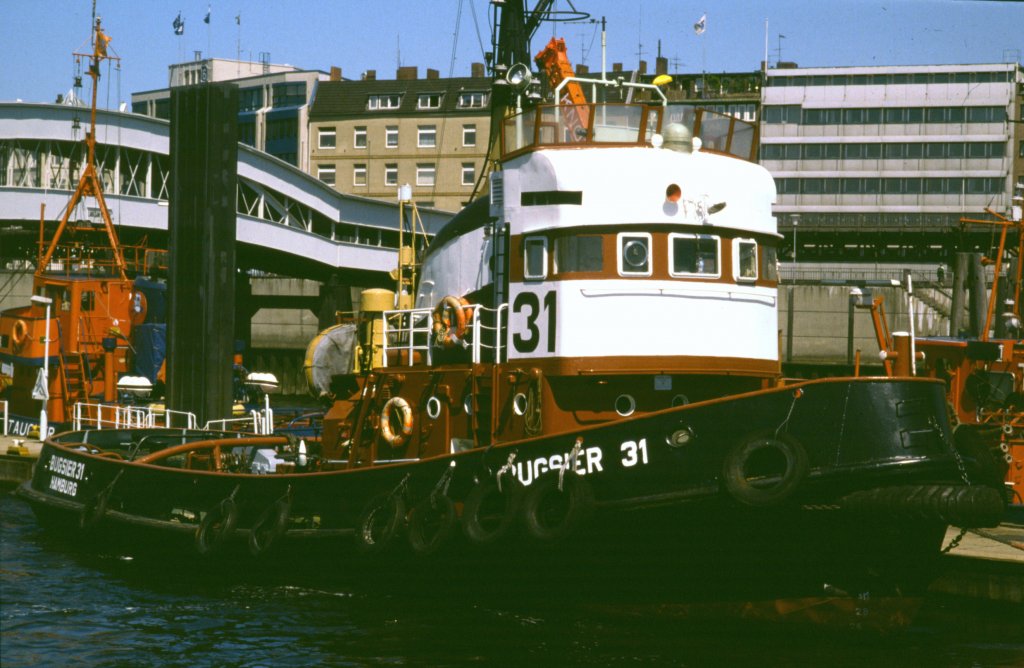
[309,77,490,121]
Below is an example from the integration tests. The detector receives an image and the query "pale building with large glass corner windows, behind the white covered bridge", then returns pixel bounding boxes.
[131,53,327,171]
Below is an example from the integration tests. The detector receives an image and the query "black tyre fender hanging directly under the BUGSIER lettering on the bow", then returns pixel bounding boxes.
[522,473,594,543]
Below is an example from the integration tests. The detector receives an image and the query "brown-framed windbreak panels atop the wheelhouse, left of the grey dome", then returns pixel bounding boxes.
[502,102,665,157]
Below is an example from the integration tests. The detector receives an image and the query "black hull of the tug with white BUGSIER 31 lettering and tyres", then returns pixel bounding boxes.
[19,379,1002,586]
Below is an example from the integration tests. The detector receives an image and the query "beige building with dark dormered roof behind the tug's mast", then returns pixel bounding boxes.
[309,64,490,211]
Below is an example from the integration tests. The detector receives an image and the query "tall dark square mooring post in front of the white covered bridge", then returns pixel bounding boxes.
[167,83,239,424]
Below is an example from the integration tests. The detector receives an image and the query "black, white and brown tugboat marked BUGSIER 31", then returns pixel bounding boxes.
[18,3,1004,590]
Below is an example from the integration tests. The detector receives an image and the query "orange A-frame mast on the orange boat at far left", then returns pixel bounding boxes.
[36,17,128,281]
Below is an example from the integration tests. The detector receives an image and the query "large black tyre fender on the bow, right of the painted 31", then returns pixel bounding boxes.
[722,432,808,506]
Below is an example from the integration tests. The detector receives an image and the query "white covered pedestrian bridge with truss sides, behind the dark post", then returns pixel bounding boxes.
[0,102,451,280]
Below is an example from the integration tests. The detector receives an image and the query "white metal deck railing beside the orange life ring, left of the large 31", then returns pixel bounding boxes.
[383,304,508,367]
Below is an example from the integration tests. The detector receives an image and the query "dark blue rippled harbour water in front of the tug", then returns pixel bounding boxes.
[0,495,1024,668]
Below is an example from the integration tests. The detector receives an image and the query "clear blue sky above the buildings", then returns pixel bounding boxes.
[0,0,1024,108]
